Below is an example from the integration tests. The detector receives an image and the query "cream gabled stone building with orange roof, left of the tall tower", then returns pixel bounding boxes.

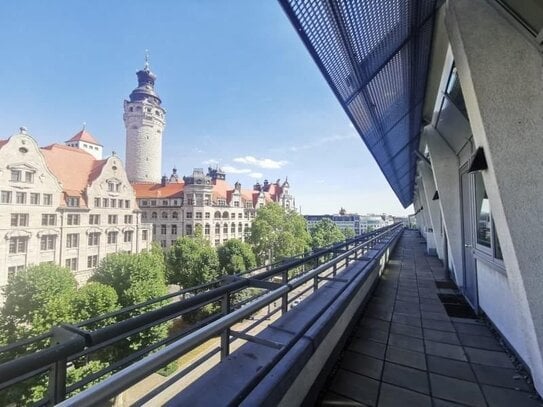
[0,128,151,286]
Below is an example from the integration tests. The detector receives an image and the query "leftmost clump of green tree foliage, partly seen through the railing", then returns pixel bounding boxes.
[0,263,118,405]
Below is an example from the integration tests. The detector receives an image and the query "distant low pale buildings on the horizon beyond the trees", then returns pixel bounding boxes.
[304,214,394,235]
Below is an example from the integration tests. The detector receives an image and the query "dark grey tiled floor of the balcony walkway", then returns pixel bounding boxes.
[321,231,542,407]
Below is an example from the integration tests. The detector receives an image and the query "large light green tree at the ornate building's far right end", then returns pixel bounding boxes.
[249,203,311,264]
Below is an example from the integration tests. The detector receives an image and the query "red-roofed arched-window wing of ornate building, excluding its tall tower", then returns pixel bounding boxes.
[132,168,295,248]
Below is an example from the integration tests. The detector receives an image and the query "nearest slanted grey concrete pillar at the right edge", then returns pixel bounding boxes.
[446,0,543,392]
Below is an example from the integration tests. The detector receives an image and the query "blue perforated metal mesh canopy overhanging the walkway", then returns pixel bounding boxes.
[279,0,436,207]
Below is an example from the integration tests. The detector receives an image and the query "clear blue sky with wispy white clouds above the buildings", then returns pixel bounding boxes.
[0,0,408,215]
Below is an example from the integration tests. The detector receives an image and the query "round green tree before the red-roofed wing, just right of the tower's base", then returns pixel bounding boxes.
[166,234,223,288]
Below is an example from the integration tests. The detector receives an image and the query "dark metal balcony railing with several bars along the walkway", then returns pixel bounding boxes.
[0,225,402,406]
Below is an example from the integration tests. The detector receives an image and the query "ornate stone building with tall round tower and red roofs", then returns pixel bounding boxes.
[124,61,295,247]
